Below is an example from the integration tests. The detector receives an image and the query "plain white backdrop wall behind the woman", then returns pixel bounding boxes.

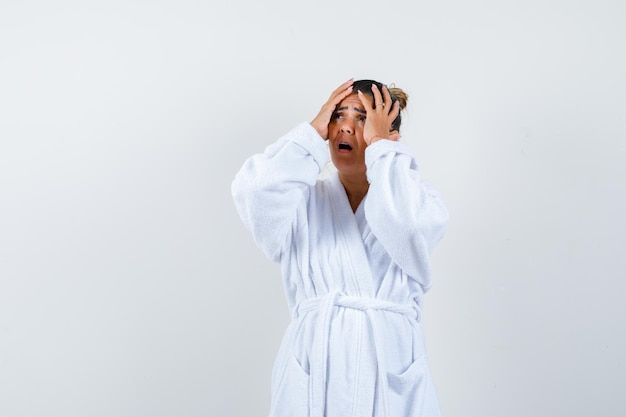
[0,0,626,417]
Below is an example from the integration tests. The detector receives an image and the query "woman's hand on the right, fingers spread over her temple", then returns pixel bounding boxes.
[358,84,400,146]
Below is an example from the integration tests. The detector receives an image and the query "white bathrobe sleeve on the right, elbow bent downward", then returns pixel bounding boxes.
[364,139,448,290]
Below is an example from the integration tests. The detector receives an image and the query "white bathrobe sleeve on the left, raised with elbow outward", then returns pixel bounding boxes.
[231,123,329,262]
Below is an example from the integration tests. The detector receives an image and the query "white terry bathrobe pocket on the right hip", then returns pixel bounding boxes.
[387,356,440,417]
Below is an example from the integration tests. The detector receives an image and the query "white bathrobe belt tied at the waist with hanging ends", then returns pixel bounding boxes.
[293,291,421,417]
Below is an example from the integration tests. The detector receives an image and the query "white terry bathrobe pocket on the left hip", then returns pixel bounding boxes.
[270,354,309,417]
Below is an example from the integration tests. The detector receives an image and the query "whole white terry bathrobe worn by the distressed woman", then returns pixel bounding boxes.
[232,123,448,417]
